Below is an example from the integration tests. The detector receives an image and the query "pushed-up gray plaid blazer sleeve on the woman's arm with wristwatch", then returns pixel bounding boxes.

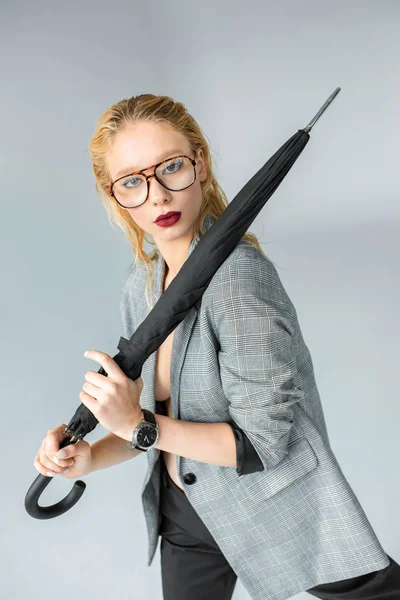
[212,247,304,470]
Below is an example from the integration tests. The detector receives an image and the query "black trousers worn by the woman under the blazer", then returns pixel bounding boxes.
[160,456,400,600]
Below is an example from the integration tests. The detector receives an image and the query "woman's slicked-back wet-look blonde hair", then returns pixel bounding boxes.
[89,94,267,308]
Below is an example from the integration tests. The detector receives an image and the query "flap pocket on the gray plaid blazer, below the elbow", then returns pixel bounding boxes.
[246,438,318,501]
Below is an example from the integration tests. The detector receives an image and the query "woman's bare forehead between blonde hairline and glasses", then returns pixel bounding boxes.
[106,121,190,177]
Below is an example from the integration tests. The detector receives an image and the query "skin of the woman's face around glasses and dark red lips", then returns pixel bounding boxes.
[106,121,207,250]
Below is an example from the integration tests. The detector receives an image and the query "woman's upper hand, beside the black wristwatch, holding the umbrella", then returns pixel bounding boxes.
[79,350,143,440]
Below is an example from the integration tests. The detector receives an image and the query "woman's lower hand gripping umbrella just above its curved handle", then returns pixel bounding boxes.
[33,423,92,479]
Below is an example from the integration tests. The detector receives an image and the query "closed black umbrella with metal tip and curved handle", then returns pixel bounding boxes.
[25,87,341,519]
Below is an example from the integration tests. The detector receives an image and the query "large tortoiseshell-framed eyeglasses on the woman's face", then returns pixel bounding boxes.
[110,155,196,208]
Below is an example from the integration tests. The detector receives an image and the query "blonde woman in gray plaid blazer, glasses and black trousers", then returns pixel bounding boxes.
[34,94,400,600]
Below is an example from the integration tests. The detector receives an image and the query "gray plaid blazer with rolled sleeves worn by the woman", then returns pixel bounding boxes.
[120,216,389,600]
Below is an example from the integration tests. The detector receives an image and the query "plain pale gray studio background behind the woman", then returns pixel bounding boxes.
[0,0,400,600]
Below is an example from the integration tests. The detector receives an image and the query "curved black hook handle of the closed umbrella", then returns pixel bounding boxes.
[25,429,86,519]
